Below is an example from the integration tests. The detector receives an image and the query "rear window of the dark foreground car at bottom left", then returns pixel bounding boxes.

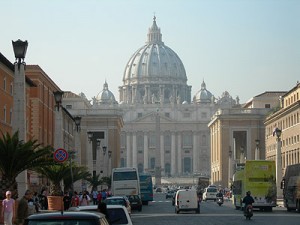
[28,219,95,225]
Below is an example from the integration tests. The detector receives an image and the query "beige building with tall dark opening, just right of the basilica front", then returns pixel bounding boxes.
[208,92,284,187]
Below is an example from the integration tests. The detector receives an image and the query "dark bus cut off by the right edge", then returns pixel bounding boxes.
[281,164,300,212]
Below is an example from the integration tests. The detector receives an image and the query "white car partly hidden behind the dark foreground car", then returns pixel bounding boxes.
[69,205,133,225]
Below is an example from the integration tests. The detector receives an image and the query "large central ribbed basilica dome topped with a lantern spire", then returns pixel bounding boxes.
[119,17,191,104]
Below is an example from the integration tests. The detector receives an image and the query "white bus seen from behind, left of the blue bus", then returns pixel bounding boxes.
[111,167,141,197]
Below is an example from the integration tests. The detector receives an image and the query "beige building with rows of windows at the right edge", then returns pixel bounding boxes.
[265,82,300,174]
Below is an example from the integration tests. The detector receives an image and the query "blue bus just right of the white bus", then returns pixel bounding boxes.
[139,173,153,205]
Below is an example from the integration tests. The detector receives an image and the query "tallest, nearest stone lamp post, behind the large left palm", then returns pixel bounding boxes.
[12,39,28,197]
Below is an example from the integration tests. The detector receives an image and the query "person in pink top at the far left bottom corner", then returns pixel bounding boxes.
[1,191,15,225]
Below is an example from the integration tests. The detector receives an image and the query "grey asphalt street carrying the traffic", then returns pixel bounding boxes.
[132,193,300,225]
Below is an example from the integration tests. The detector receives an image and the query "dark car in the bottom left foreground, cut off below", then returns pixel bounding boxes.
[23,211,109,225]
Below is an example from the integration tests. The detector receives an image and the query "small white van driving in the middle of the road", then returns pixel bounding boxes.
[175,189,200,214]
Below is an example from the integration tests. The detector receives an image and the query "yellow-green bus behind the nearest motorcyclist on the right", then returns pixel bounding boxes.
[232,160,277,211]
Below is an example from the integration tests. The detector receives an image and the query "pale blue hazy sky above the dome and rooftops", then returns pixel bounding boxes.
[0,0,300,103]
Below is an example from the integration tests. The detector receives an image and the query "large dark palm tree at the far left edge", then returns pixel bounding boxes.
[0,131,53,199]
